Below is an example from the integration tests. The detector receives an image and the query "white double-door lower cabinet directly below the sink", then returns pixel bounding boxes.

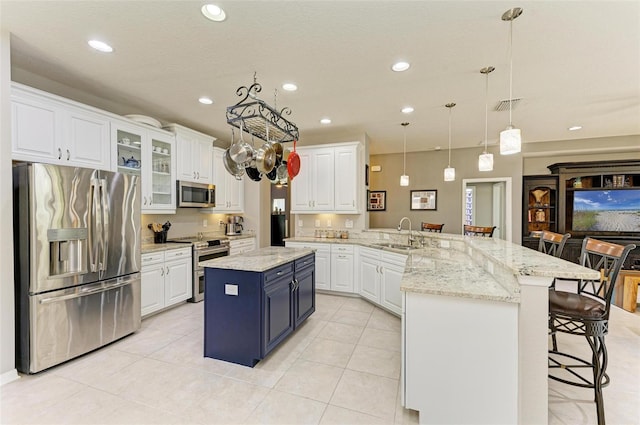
[358,247,407,314]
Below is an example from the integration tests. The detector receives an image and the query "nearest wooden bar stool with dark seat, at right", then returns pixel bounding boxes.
[549,237,636,425]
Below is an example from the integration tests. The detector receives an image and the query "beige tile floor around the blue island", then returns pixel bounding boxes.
[0,294,640,425]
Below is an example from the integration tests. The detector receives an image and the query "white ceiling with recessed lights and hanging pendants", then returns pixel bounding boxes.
[0,0,640,154]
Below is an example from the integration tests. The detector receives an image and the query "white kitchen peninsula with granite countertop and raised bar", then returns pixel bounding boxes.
[291,229,599,424]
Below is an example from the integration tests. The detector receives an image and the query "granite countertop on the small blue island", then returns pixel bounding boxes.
[200,246,315,272]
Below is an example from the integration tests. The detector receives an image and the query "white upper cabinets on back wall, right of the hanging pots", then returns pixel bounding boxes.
[291,142,364,214]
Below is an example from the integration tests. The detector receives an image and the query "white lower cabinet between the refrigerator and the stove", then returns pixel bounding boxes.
[141,248,193,317]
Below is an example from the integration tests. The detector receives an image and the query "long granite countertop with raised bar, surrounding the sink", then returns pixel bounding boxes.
[287,229,599,302]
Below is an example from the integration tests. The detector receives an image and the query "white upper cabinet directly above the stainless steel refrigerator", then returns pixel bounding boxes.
[11,83,111,170]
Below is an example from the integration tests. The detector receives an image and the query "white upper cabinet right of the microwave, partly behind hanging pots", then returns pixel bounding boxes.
[211,148,244,213]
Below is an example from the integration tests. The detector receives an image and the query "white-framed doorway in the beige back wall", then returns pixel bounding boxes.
[462,177,513,242]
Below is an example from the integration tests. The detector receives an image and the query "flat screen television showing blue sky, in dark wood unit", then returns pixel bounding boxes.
[571,188,640,234]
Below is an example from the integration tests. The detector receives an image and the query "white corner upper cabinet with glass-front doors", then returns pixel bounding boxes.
[111,121,176,214]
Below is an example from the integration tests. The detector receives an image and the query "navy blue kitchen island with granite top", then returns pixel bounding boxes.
[200,247,316,367]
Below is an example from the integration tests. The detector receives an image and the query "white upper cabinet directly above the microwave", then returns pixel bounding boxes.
[164,124,216,184]
